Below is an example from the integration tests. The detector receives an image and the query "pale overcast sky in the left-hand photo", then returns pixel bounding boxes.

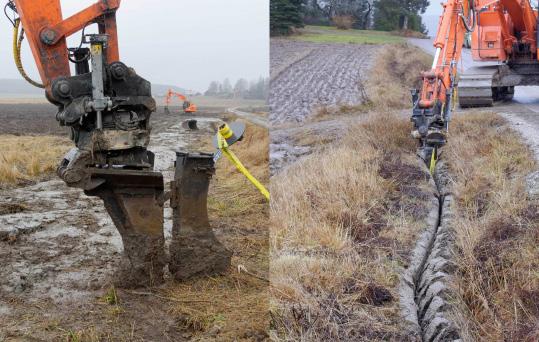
[0,0,269,91]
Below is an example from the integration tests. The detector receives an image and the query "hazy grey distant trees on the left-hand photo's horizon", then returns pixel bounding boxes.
[204,77,269,100]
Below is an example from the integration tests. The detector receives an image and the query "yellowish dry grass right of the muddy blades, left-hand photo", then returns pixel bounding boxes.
[164,125,269,341]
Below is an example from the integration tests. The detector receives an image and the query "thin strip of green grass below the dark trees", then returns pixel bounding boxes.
[293,26,404,44]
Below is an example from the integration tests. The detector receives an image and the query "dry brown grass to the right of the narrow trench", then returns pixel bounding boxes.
[445,113,539,341]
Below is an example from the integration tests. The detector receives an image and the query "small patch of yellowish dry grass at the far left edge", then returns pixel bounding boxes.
[0,135,72,188]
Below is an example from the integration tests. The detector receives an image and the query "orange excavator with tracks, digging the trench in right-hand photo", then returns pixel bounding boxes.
[412,0,539,165]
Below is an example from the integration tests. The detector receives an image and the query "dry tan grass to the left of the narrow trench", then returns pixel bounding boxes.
[271,114,429,341]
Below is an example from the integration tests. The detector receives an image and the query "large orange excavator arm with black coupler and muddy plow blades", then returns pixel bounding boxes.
[4,0,231,287]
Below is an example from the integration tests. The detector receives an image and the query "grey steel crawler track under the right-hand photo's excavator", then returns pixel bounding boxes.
[458,65,499,108]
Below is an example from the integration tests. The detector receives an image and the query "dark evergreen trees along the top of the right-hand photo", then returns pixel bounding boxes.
[270,0,429,35]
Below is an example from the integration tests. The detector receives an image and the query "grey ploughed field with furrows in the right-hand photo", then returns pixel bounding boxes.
[270,39,380,174]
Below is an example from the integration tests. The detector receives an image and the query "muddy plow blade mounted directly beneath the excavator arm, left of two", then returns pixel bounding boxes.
[85,169,166,287]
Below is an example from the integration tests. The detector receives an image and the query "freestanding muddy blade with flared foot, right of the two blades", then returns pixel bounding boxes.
[169,152,232,280]
